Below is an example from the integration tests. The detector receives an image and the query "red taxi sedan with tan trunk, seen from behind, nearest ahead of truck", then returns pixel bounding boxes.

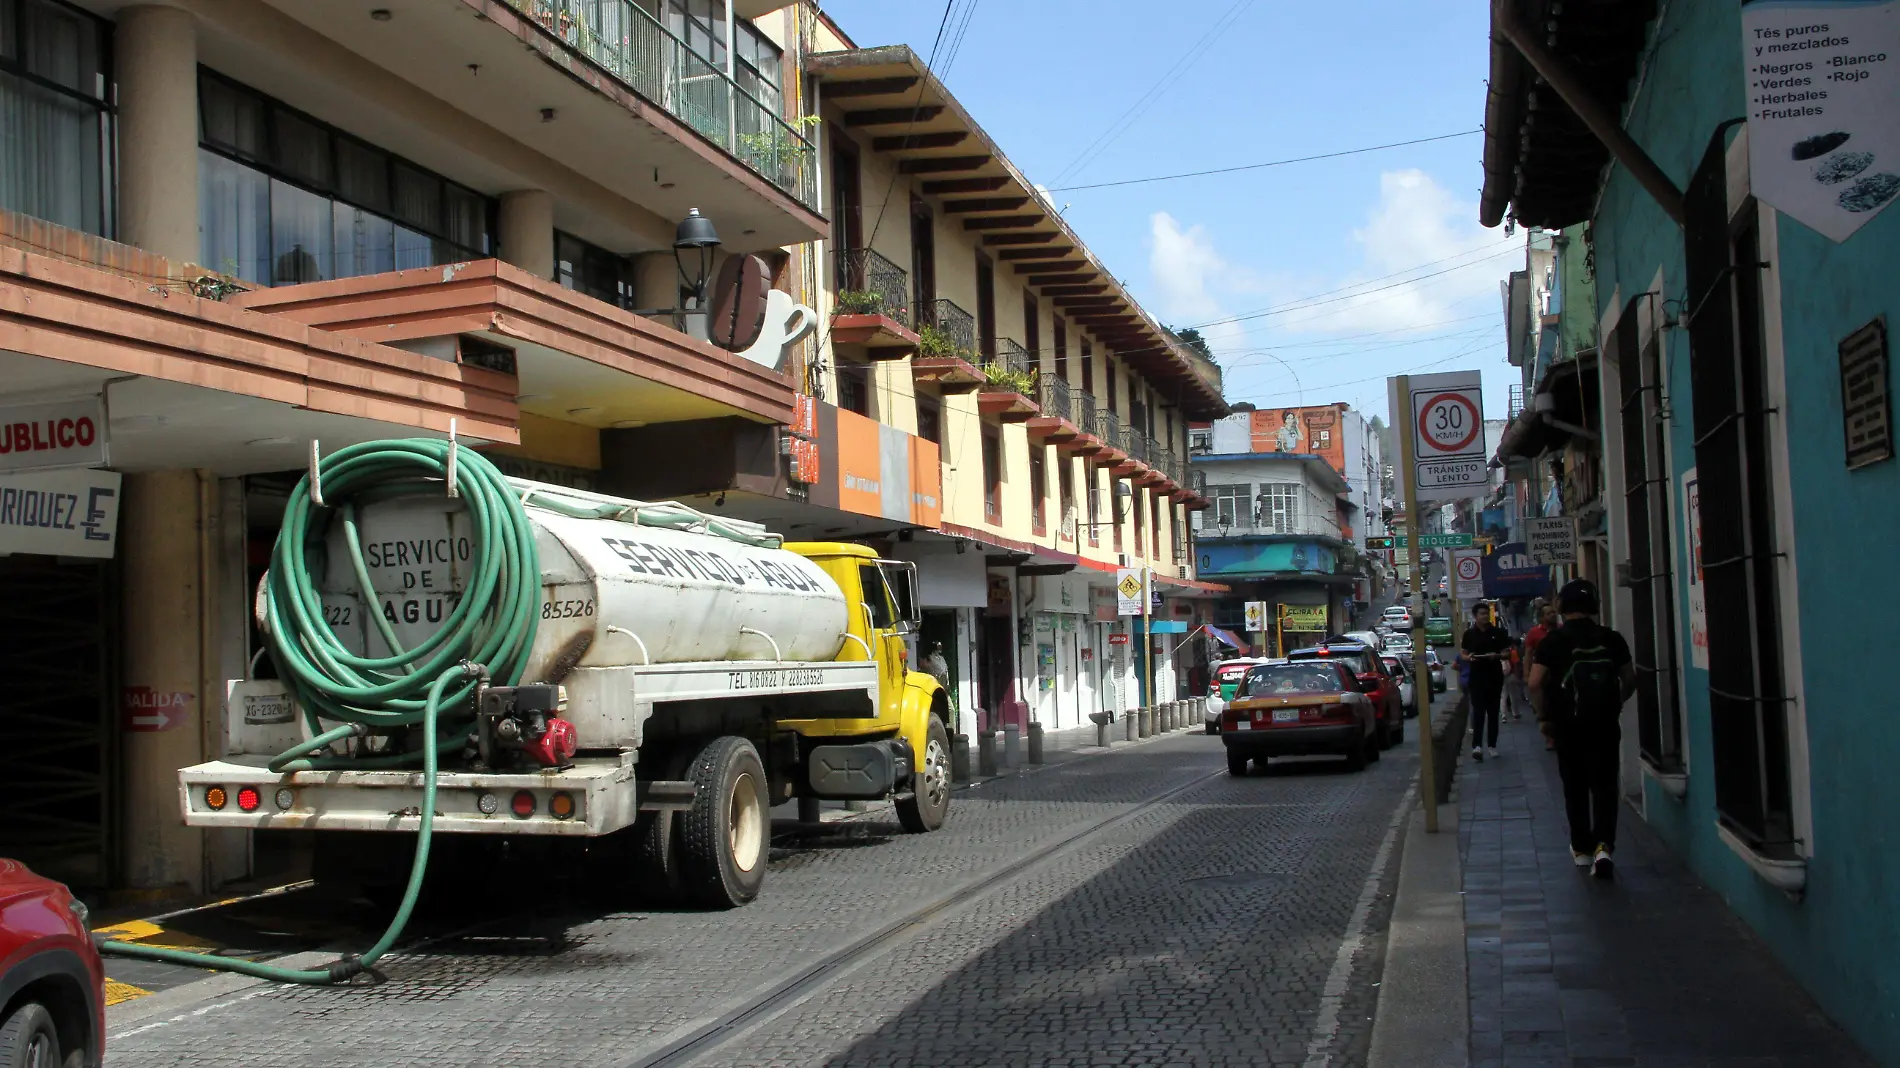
[1220,659,1379,775]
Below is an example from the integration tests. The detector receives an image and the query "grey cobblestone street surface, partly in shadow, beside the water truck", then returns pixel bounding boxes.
[108,706,1417,1068]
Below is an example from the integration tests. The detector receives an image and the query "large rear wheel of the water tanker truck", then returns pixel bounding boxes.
[678,735,771,908]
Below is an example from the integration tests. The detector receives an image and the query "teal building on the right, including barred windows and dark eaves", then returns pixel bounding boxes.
[1482,0,1900,1062]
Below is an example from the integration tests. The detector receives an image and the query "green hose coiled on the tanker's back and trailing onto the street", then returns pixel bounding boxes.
[99,439,542,984]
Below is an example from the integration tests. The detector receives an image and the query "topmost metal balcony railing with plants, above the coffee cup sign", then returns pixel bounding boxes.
[507,0,817,211]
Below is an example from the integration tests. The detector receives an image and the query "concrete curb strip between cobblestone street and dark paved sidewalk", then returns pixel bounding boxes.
[1366,804,1471,1068]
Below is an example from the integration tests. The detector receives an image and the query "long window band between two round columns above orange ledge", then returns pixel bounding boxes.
[198,70,494,285]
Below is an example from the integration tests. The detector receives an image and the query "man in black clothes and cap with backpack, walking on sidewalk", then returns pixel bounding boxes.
[1530,578,1636,878]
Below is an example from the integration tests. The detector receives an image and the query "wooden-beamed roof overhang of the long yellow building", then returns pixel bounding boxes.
[806,44,1229,420]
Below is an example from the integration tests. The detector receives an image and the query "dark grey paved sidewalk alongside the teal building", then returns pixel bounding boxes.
[1457,718,1872,1068]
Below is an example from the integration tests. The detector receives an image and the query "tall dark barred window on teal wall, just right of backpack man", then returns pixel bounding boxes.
[1604,295,1682,772]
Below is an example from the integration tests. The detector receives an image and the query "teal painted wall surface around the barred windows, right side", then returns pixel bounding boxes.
[1596,0,1900,1066]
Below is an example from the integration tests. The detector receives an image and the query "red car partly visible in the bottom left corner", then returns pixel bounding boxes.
[0,859,106,1068]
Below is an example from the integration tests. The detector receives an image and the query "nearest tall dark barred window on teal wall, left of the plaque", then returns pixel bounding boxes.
[1683,120,1794,853]
